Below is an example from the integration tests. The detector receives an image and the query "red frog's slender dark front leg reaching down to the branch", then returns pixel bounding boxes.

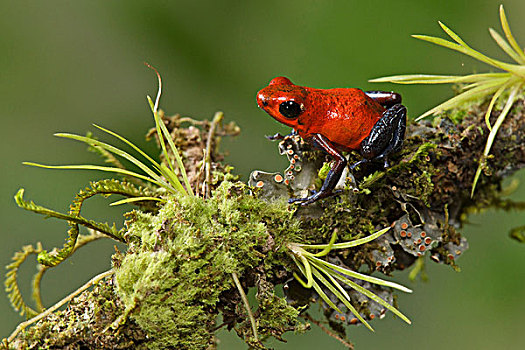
[288,134,347,205]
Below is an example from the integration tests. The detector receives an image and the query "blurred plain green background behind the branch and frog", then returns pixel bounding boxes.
[0,0,525,350]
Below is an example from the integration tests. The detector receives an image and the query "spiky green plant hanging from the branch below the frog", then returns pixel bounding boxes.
[287,227,412,331]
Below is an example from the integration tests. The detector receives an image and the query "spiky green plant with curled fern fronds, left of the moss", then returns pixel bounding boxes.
[5,65,193,316]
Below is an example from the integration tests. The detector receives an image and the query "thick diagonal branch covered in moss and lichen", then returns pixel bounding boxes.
[5,92,525,349]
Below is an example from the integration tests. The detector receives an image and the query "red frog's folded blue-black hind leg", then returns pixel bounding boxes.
[350,104,407,169]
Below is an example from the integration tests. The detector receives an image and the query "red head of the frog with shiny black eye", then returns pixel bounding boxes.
[257,77,306,128]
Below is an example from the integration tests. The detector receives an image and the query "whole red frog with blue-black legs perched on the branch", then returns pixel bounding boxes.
[257,77,406,205]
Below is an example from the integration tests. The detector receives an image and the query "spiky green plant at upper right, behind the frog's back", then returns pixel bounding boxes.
[370,5,525,196]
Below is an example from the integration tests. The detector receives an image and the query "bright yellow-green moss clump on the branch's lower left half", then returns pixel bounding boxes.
[115,181,298,349]
